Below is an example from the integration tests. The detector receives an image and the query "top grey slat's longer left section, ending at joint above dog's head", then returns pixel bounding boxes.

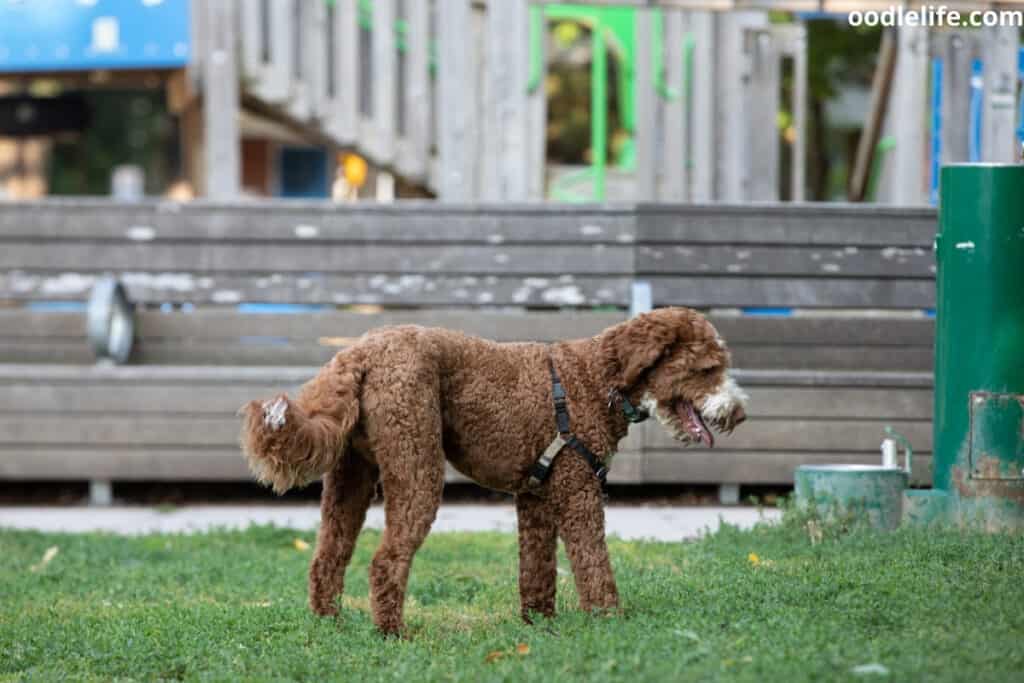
[0,200,636,246]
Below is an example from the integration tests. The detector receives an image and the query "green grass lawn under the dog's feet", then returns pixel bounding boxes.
[0,522,1024,683]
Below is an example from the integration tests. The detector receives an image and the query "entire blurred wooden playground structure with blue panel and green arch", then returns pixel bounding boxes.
[0,0,1024,205]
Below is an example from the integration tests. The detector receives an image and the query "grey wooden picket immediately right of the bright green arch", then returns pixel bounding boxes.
[633,9,658,202]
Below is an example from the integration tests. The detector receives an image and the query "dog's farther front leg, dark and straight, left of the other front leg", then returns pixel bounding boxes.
[515,494,558,624]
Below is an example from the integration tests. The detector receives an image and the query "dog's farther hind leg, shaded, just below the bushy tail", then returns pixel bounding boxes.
[309,450,378,616]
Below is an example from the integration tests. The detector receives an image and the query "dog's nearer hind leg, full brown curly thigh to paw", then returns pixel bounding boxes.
[367,375,444,634]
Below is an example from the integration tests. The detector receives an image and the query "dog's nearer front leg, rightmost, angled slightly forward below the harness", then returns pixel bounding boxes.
[550,452,618,611]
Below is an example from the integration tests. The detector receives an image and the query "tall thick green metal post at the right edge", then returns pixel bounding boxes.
[934,164,1024,529]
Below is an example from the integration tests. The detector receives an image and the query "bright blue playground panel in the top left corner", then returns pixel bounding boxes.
[0,0,190,73]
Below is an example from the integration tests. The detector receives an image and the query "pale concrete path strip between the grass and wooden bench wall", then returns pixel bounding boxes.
[0,504,779,541]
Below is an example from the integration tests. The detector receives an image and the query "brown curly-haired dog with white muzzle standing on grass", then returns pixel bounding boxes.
[242,308,746,633]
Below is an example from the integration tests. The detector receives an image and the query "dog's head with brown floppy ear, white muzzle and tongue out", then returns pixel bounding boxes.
[599,308,748,447]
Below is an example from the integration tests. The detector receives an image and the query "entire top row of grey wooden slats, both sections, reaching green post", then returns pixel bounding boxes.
[0,199,937,249]
